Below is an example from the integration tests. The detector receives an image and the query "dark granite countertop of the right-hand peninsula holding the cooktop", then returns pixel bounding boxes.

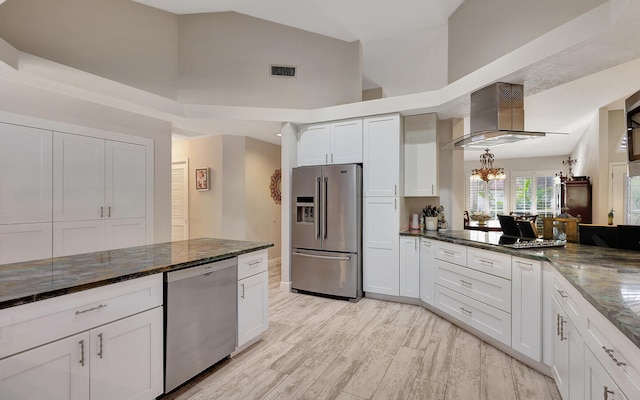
[400,230,640,347]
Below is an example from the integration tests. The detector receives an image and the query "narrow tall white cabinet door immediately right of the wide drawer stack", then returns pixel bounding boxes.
[511,257,542,361]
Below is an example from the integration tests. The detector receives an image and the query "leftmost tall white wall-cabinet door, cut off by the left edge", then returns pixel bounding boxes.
[0,124,53,224]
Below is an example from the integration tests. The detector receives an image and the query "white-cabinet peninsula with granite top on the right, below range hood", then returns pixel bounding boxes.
[400,230,640,400]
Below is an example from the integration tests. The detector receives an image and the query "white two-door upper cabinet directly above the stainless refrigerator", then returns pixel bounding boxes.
[298,118,362,166]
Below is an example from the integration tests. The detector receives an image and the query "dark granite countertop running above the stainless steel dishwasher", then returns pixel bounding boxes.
[0,238,273,309]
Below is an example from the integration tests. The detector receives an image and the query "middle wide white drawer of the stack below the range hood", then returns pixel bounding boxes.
[436,260,511,313]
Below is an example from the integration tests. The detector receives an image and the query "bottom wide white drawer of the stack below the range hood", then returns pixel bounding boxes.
[435,284,511,346]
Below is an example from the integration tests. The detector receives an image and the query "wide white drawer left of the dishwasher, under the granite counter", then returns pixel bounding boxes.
[0,274,163,358]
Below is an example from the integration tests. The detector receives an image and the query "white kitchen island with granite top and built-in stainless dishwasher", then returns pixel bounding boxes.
[0,238,273,399]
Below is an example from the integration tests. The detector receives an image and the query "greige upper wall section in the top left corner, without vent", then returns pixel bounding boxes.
[0,0,178,98]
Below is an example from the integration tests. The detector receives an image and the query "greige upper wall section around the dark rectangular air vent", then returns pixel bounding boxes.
[178,12,362,108]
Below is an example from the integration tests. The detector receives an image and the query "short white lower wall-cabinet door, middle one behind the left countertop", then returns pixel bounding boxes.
[53,220,105,257]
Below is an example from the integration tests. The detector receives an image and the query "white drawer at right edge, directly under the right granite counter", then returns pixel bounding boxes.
[584,309,640,399]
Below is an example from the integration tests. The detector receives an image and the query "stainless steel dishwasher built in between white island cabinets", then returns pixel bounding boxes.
[164,257,238,393]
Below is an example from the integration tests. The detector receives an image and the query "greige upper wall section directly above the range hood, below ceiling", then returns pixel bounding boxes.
[448,0,605,82]
